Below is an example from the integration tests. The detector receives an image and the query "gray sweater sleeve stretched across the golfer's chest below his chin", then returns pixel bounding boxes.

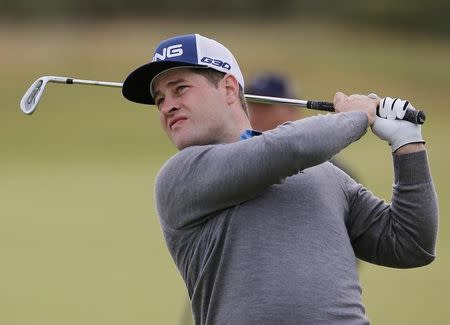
[156,112,367,229]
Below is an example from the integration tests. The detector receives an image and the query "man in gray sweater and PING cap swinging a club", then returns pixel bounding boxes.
[123,34,437,325]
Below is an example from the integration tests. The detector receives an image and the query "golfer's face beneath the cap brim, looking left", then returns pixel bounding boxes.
[153,68,229,150]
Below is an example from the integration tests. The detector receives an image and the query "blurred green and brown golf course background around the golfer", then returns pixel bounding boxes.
[0,0,450,325]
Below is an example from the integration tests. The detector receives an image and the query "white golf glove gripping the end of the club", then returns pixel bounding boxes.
[371,94,425,152]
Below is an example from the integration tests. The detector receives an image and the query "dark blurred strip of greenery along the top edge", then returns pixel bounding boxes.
[0,0,450,36]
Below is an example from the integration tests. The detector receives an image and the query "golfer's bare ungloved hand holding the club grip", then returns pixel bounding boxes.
[333,92,380,126]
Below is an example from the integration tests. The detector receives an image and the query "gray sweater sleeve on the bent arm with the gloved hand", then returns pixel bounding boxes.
[348,151,438,268]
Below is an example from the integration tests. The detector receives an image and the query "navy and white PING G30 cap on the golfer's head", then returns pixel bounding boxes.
[122,34,244,104]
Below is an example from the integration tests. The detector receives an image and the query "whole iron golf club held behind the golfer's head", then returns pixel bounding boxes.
[20,76,425,124]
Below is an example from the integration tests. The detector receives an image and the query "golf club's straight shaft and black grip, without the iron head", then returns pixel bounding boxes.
[41,77,425,124]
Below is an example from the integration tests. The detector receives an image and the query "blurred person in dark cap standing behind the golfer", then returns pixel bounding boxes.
[246,72,357,180]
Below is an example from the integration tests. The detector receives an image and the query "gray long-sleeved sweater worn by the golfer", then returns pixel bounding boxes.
[156,112,438,325]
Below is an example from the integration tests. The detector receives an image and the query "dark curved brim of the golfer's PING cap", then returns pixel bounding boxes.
[122,61,203,105]
